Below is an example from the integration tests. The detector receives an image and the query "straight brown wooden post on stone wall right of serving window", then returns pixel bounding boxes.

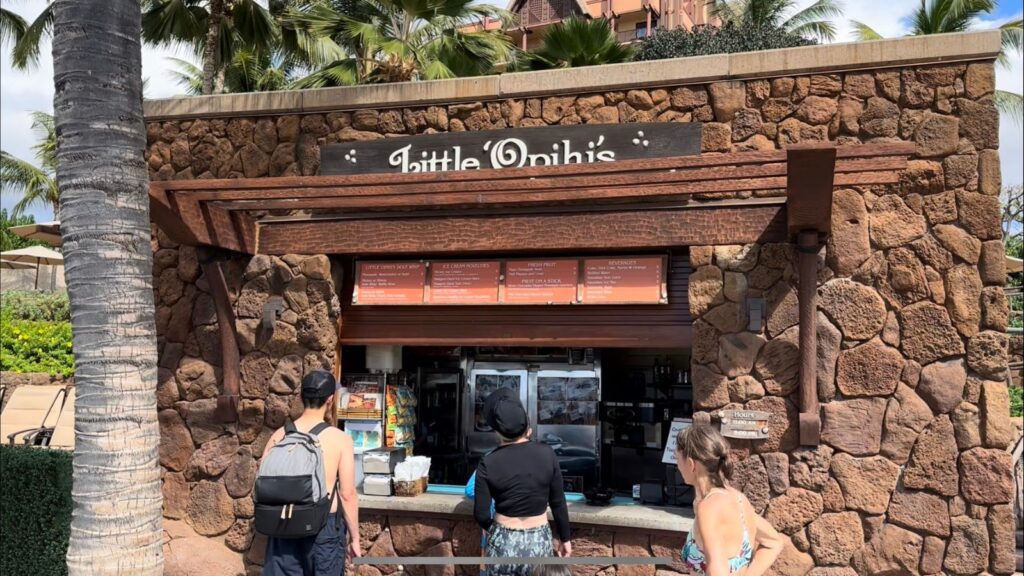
[797,231,821,446]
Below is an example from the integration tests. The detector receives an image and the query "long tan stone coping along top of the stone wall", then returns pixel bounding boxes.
[143,30,1000,121]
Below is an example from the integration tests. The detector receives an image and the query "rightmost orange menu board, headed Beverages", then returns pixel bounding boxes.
[583,256,665,304]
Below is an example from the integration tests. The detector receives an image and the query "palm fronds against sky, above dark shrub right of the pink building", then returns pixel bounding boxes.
[712,0,843,41]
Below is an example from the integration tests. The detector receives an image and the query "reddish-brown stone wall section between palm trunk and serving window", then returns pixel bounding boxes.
[154,232,340,575]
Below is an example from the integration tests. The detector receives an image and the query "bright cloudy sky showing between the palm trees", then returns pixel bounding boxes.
[0,0,1024,221]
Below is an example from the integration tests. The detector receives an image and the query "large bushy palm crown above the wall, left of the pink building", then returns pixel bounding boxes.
[281,0,515,88]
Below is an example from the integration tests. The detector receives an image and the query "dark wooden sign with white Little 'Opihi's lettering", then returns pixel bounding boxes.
[321,122,700,175]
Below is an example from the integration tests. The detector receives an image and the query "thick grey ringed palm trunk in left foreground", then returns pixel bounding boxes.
[53,0,163,576]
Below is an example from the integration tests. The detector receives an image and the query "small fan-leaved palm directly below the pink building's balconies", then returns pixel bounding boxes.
[528,17,633,70]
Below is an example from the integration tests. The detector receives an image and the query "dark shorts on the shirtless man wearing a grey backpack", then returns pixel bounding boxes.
[263,510,348,576]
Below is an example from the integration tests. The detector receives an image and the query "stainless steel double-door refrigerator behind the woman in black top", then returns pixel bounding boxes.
[465,360,601,492]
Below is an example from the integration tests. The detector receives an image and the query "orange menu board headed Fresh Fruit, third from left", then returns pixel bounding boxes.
[502,260,580,304]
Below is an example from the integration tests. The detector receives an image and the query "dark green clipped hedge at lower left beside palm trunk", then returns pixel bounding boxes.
[0,445,72,576]
